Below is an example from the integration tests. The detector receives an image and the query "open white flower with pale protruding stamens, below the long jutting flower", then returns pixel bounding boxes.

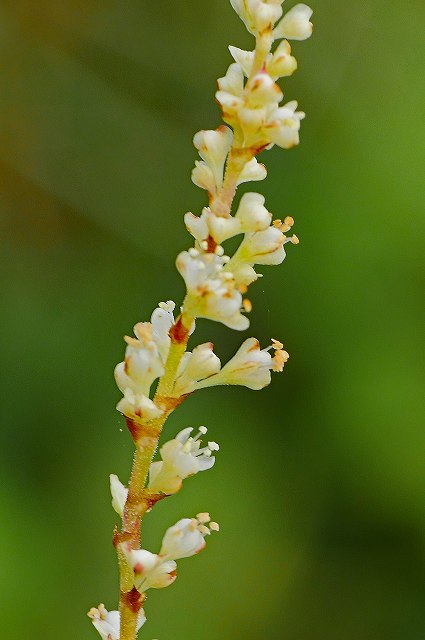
[148,427,219,495]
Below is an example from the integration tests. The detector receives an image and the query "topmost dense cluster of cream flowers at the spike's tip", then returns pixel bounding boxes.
[216,0,313,150]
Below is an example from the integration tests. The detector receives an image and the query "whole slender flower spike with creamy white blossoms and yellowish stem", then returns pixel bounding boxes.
[88,0,312,640]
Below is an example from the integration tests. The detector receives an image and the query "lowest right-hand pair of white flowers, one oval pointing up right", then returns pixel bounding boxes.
[122,513,219,593]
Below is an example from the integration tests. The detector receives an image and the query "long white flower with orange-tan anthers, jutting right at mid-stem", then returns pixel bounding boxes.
[196,338,289,391]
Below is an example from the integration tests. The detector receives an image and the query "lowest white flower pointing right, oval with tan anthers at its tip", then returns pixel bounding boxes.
[159,513,218,560]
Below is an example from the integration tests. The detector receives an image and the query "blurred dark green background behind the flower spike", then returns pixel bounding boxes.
[0,0,425,640]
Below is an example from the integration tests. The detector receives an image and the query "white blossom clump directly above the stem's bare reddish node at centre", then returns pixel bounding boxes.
[176,249,249,331]
